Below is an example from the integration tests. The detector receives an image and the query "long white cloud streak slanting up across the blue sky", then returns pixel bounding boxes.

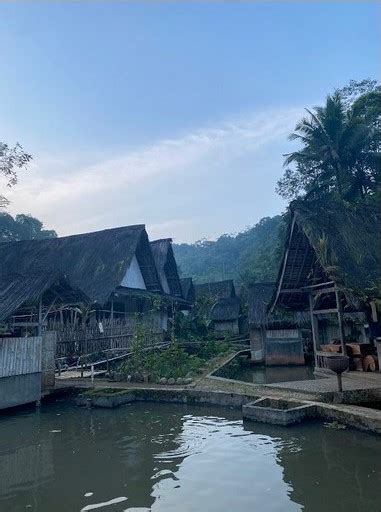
[7,108,301,239]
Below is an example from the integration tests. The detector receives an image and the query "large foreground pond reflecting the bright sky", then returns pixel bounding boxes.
[0,402,381,512]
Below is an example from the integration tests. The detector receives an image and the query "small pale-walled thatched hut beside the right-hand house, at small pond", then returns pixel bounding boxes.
[248,283,310,366]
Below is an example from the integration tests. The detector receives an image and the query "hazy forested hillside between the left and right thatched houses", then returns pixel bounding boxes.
[174,215,285,284]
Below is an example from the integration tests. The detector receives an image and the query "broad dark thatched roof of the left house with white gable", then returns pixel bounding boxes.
[0,225,162,318]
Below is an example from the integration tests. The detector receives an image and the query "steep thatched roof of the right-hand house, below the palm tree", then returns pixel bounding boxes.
[274,199,381,309]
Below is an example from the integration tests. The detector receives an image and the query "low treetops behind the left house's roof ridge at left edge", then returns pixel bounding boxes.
[0,212,57,242]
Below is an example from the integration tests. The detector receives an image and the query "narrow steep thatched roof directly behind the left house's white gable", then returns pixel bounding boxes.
[150,238,183,298]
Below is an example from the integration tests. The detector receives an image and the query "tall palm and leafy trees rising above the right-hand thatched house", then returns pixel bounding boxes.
[277,80,381,201]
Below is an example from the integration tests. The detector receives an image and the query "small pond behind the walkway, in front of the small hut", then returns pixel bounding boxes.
[215,357,316,384]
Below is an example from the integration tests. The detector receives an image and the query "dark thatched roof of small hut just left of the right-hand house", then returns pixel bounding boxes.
[248,283,310,329]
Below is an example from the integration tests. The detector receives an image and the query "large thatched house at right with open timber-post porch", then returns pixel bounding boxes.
[272,199,381,366]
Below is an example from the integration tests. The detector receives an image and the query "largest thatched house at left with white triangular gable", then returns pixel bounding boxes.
[0,225,171,354]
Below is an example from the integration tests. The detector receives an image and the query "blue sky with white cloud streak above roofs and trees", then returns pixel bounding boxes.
[0,1,381,242]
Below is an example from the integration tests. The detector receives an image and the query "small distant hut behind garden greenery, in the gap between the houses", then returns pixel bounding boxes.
[210,297,242,334]
